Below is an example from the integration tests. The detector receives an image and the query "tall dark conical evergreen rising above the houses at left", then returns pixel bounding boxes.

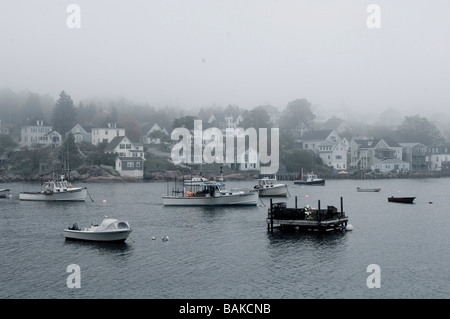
[52,91,77,135]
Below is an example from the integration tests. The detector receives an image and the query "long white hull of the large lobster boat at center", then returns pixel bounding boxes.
[163,192,258,206]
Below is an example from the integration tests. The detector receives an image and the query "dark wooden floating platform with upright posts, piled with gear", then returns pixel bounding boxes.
[267,197,353,232]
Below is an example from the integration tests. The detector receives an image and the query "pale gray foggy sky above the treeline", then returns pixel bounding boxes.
[0,0,450,113]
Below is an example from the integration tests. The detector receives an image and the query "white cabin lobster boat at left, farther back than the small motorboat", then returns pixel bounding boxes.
[19,175,87,202]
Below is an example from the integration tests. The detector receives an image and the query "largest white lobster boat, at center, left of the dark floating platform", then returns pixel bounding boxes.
[162,181,259,206]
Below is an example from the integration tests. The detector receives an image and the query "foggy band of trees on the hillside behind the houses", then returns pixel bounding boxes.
[0,89,450,178]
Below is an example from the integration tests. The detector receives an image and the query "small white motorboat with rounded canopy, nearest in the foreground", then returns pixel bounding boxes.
[64,217,133,242]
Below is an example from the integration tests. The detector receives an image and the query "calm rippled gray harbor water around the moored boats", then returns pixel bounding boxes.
[0,178,450,299]
